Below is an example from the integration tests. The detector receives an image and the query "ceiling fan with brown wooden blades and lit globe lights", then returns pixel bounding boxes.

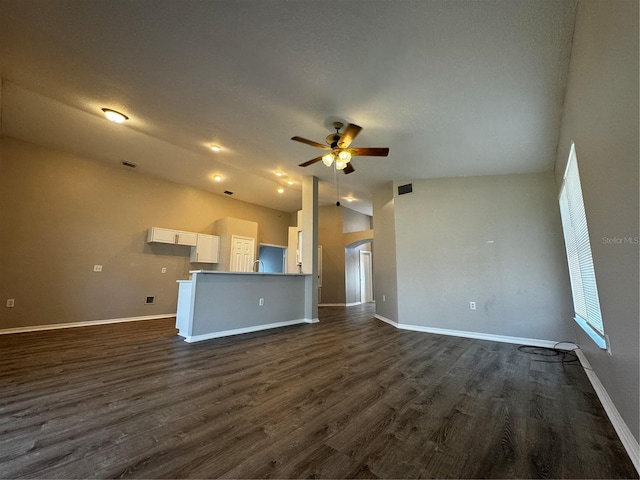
[291,122,389,173]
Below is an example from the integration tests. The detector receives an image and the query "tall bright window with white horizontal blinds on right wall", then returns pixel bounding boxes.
[559,144,607,349]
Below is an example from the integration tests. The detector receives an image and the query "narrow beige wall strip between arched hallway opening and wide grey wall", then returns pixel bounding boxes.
[373,182,398,323]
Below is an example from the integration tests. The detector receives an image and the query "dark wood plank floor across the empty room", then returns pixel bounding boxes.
[0,306,638,478]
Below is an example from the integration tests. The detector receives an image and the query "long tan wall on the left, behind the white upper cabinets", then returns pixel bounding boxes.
[0,137,291,329]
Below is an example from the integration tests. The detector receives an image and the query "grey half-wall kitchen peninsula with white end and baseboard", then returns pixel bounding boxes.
[176,270,317,342]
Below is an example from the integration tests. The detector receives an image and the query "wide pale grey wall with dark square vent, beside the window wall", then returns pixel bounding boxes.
[396,172,575,341]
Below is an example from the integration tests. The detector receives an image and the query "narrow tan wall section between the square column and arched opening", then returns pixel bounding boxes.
[318,205,346,304]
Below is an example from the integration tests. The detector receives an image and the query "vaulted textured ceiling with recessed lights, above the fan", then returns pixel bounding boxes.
[0,0,575,214]
